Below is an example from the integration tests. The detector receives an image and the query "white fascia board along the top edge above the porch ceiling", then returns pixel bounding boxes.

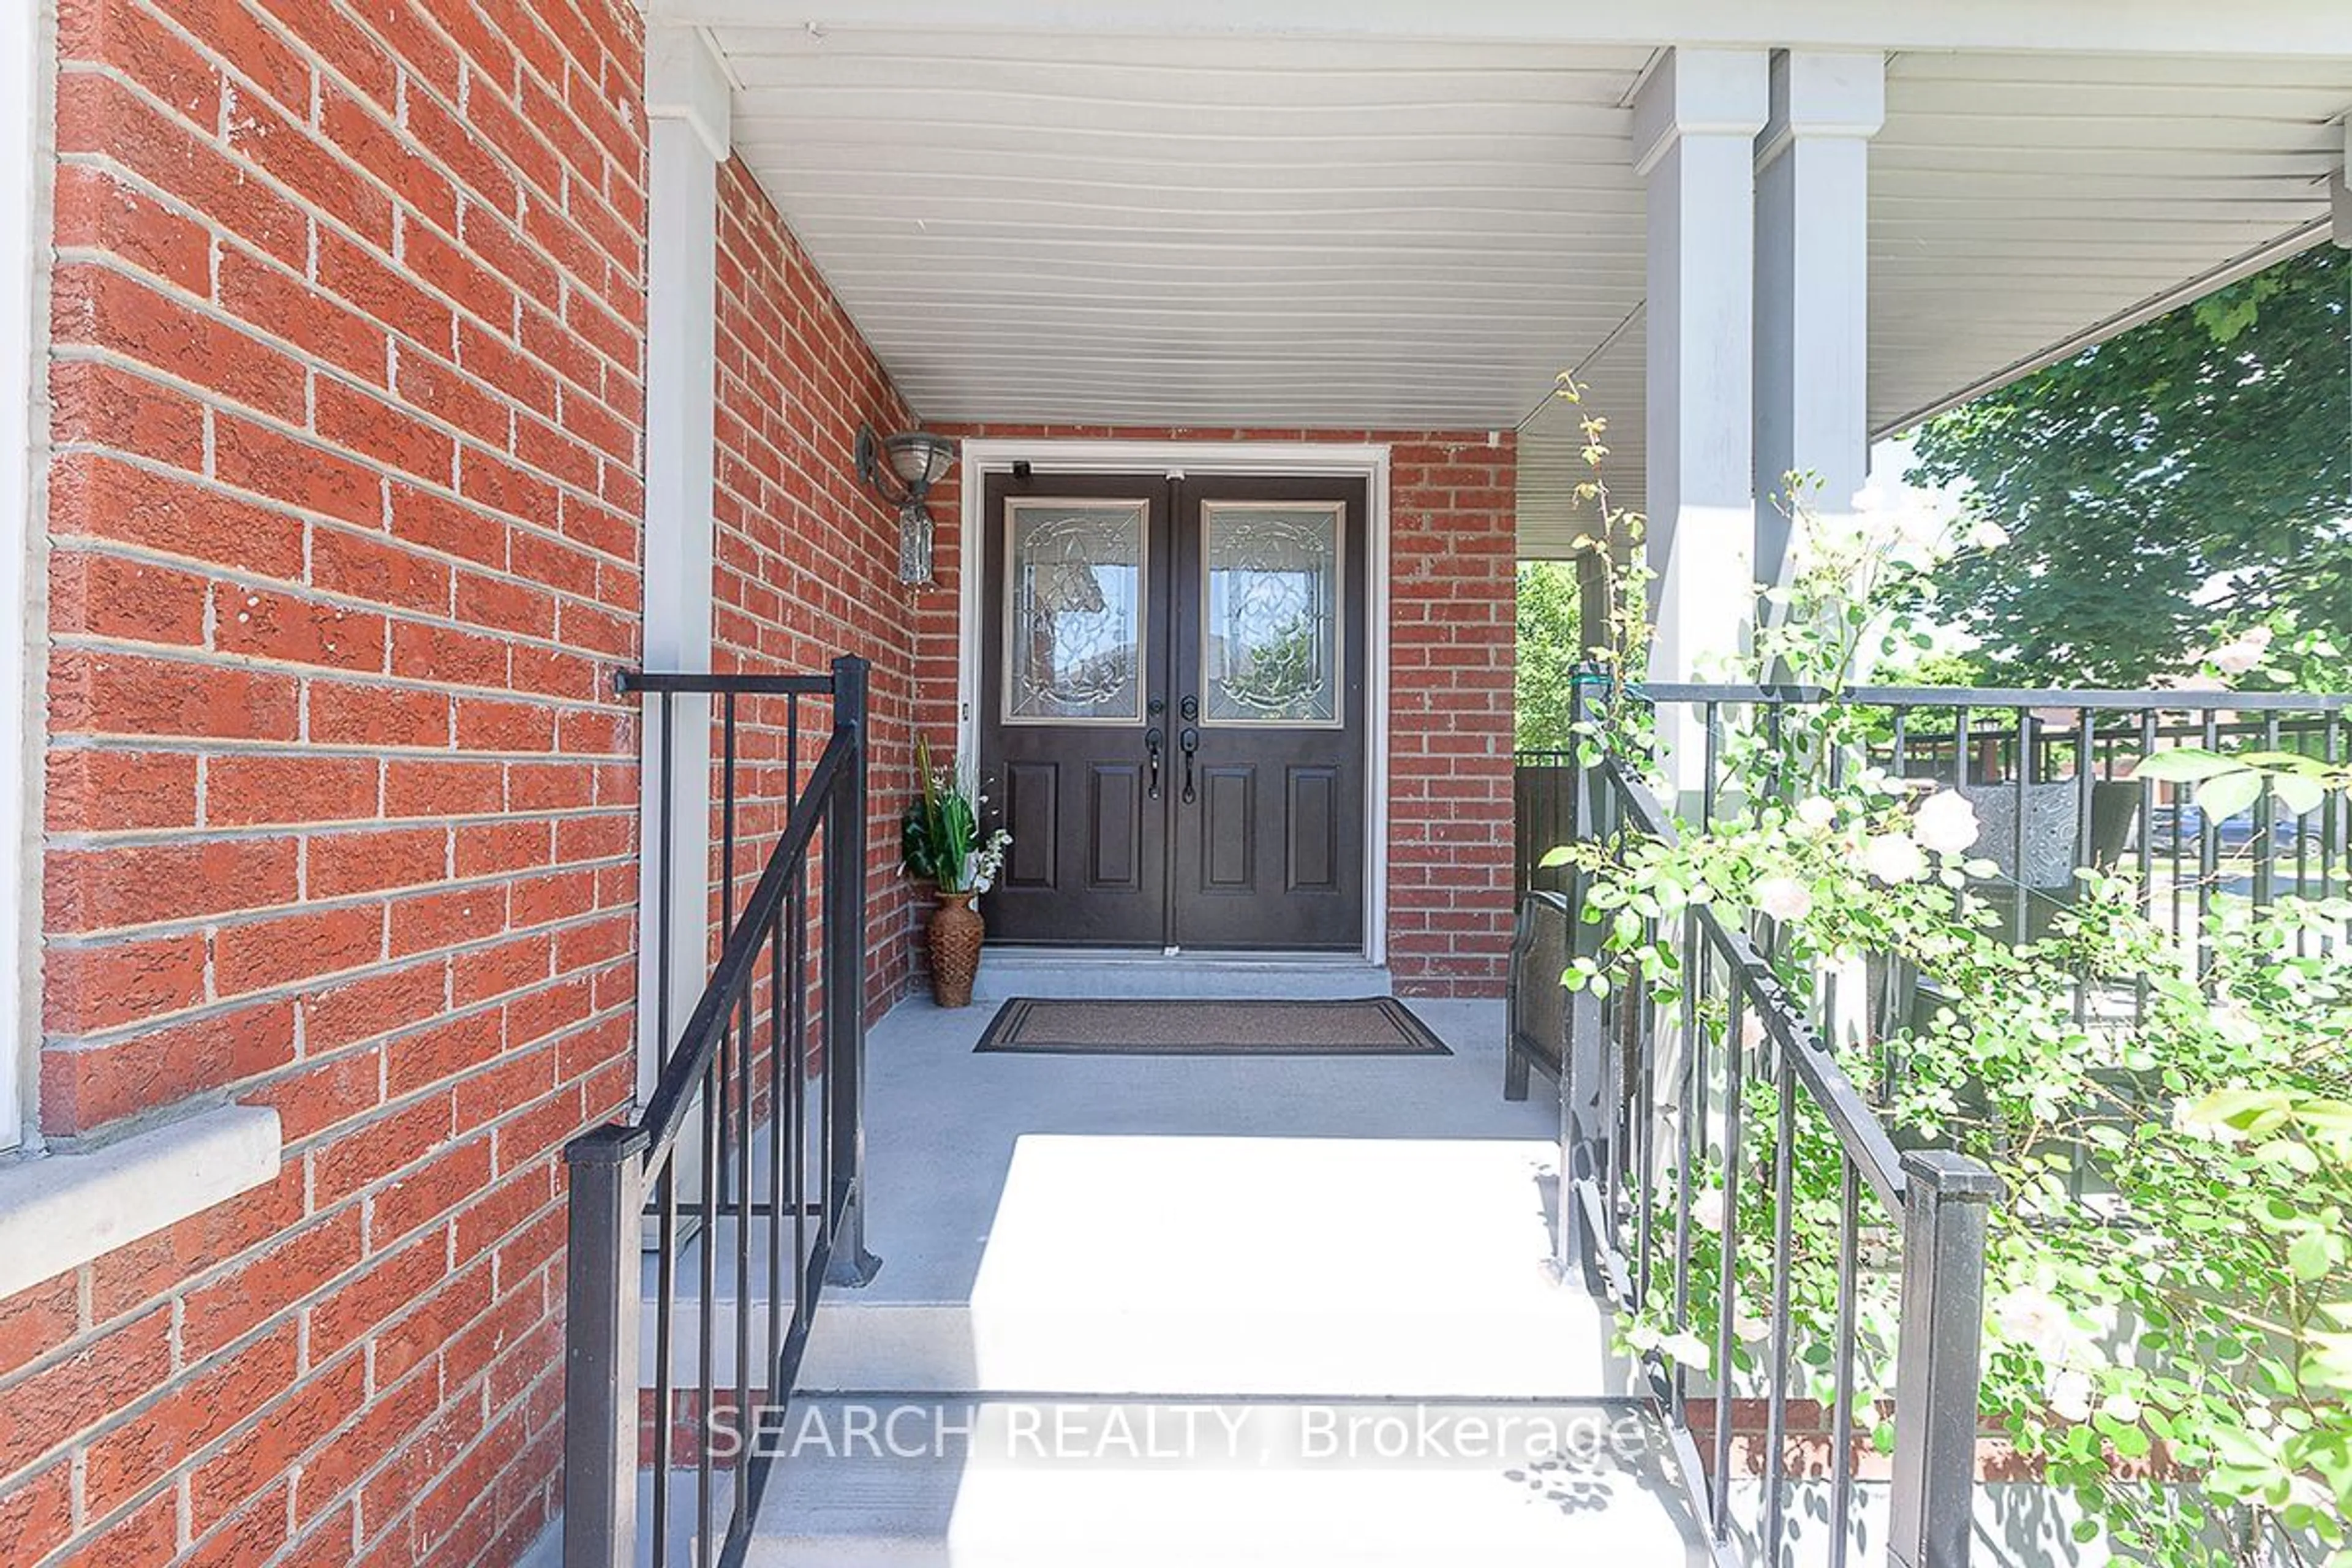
[647,0,2352,59]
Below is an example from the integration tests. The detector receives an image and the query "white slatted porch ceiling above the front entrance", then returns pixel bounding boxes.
[713,21,2352,555]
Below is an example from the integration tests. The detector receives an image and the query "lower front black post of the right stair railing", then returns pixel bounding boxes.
[1889,1150,2002,1568]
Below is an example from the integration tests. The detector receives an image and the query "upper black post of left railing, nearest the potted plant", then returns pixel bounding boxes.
[823,658,882,1286]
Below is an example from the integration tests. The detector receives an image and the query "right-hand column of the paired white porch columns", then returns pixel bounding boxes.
[1755,50,1887,614]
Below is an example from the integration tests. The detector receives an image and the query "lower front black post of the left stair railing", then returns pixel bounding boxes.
[565,1126,663,1568]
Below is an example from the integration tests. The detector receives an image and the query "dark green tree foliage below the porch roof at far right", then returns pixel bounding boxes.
[1912,244,2352,687]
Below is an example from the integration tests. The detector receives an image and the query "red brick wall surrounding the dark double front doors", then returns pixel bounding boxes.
[915,423,1517,997]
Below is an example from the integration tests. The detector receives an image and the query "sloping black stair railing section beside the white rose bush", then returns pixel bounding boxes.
[1529,760,1999,1568]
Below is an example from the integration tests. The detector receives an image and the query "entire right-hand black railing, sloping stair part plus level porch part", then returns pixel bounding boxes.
[1506,684,2352,1568]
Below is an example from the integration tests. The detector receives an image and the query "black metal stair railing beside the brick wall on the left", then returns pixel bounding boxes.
[565,658,877,1568]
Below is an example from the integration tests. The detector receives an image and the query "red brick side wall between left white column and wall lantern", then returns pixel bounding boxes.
[710,160,915,1011]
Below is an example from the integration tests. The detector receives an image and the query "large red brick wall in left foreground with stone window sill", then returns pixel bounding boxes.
[0,0,644,1566]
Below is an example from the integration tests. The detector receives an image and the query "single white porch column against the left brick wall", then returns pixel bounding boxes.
[638,26,731,1093]
